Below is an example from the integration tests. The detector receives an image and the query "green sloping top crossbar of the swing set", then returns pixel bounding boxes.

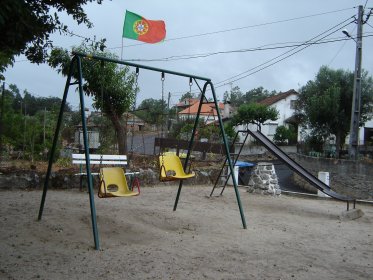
[72,51,211,82]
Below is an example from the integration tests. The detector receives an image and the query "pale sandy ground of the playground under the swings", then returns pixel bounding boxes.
[0,186,373,280]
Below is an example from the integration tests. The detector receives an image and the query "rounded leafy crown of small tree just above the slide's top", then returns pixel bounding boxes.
[232,103,278,130]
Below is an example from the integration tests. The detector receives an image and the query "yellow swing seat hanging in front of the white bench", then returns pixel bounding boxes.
[98,167,140,198]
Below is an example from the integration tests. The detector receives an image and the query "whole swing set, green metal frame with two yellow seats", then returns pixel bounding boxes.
[38,52,246,250]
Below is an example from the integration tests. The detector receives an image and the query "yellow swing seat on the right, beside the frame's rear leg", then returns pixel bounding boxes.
[159,154,196,181]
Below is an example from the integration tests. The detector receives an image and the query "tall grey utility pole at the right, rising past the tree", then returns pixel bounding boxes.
[348,5,364,160]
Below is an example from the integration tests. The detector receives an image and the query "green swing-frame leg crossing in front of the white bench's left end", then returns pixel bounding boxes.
[76,56,100,250]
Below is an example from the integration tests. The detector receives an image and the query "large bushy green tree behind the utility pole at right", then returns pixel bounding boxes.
[296,66,373,157]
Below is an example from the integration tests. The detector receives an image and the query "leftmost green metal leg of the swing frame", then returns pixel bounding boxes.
[38,57,76,221]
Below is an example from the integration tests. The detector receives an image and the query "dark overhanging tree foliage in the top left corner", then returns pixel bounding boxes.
[0,0,102,79]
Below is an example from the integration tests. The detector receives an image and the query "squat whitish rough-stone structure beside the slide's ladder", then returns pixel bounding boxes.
[247,162,281,195]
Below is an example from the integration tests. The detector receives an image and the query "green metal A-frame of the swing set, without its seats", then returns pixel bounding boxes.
[38,52,247,250]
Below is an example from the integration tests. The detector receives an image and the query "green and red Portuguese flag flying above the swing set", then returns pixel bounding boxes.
[123,11,166,43]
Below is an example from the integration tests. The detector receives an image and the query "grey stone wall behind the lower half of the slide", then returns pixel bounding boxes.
[292,154,373,200]
